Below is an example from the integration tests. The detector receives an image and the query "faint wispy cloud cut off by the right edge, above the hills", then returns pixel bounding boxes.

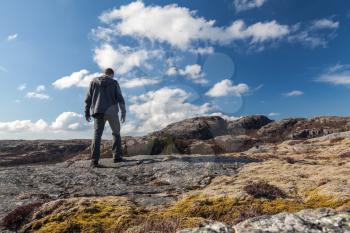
[316,64,350,85]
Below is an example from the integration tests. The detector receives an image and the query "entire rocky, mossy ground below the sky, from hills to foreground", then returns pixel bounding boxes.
[0,116,350,233]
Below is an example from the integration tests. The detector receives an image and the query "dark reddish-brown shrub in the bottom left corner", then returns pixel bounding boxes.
[1,203,42,231]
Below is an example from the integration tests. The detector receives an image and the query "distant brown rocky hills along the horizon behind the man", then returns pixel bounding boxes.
[0,115,350,163]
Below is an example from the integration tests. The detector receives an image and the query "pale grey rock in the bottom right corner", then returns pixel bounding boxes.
[234,209,350,233]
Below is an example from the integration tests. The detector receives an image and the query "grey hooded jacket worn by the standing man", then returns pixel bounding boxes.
[85,75,126,116]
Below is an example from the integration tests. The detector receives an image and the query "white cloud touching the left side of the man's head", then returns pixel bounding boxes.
[52,70,101,89]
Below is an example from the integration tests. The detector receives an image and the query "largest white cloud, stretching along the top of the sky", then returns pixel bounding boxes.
[97,0,289,50]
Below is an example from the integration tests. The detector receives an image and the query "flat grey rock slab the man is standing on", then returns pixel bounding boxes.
[0,155,255,217]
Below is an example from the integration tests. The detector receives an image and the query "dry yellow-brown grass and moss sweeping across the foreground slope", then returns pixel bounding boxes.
[4,134,350,233]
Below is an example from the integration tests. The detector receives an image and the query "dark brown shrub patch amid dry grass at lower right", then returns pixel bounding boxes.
[243,181,287,200]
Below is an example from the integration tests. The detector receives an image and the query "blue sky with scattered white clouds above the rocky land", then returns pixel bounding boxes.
[0,0,350,139]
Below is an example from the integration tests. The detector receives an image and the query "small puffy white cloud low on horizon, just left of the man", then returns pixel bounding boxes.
[50,112,88,131]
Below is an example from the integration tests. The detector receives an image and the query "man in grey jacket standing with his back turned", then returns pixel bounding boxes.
[85,68,126,167]
